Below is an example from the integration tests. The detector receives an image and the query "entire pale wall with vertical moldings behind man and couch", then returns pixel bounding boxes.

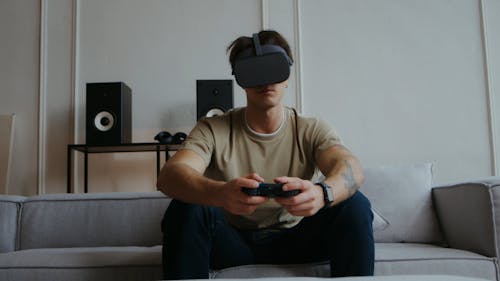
[0,0,500,194]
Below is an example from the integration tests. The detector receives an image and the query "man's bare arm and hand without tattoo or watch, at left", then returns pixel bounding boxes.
[156,150,266,214]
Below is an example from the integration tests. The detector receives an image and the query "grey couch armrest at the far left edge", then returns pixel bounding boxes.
[0,195,26,253]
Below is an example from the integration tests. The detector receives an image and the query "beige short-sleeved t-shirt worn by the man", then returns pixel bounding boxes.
[182,107,340,229]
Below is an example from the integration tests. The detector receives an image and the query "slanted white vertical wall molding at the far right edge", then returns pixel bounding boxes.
[479,0,500,176]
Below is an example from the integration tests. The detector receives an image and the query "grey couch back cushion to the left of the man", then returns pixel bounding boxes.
[18,192,170,250]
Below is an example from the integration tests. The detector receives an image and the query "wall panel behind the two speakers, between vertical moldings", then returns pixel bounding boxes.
[77,0,261,191]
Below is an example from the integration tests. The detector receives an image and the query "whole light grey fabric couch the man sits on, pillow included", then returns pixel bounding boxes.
[0,164,500,280]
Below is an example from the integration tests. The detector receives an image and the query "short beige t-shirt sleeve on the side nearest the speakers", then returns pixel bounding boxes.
[180,119,215,165]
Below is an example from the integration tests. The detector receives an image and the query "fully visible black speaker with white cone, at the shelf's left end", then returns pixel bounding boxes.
[86,82,132,145]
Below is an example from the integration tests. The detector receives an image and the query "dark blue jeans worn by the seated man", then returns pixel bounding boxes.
[162,192,374,279]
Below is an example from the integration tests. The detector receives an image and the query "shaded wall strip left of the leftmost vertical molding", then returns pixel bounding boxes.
[0,0,40,194]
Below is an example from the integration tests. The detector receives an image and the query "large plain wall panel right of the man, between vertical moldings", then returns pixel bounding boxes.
[301,0,491,182]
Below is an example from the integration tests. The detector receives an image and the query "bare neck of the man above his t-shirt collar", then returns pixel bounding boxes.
[245,105,284,134]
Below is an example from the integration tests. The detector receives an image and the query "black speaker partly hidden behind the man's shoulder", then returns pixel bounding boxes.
[196,80,233,120]
